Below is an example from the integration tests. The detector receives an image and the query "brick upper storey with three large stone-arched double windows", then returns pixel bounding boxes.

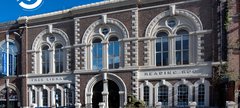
[19,0,217,73]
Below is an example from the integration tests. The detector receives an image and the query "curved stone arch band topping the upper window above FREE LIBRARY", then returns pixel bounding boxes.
[32,28,70,51]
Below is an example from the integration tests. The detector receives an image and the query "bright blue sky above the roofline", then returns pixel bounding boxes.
[0,0,103,23]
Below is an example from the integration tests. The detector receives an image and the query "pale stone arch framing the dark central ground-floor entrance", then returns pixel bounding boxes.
[85,73,127,107]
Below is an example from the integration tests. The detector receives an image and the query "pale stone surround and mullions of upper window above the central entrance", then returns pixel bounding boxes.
[82,16,129,70]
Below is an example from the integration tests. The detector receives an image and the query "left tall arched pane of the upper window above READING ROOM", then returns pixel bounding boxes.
[156,32,169,66]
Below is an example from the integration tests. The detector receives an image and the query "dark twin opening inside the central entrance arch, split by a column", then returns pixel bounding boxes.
[92,80,120,108]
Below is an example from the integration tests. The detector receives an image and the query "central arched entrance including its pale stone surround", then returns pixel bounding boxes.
[85,73,127,108]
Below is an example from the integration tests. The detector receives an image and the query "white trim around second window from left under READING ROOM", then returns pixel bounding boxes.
[155,79,173,107]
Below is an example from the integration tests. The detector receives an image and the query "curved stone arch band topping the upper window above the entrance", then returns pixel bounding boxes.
[82,18,129,44]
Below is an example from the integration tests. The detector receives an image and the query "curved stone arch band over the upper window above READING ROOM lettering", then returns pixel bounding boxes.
[145,9,203,37]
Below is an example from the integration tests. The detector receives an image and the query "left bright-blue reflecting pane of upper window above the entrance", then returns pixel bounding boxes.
[92,38,103,70]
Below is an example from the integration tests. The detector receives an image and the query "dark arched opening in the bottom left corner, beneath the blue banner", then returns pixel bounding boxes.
[0,88,18,108]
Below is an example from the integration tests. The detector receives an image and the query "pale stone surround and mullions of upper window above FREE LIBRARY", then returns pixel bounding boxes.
[30,28,70,74]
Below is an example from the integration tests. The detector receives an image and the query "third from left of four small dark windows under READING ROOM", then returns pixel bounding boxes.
[177,84,188,107]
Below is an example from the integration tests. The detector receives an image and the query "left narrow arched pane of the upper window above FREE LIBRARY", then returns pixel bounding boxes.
[42,46,50,74]
